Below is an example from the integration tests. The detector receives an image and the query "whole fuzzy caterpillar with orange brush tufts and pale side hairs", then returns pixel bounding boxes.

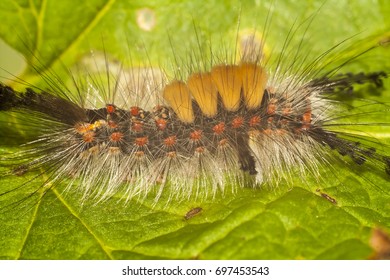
[0,3,390,208]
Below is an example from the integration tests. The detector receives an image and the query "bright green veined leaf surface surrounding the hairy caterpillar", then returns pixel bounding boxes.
[0,0,390,259]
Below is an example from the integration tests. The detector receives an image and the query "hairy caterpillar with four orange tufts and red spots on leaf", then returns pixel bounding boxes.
[4,53,390,203]
